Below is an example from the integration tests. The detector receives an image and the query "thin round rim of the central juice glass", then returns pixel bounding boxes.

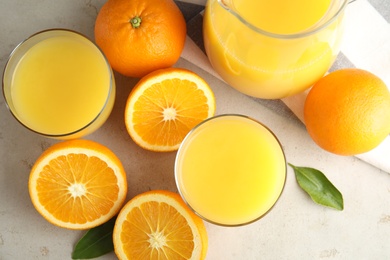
[174,113,287,227]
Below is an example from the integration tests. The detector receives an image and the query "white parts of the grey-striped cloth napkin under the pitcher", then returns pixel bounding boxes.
[182,0,390,173]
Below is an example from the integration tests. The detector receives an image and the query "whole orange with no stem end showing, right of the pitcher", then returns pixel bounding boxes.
[304,69,390,155]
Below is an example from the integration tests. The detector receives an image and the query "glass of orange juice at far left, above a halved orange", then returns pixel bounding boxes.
[3,29,115,139]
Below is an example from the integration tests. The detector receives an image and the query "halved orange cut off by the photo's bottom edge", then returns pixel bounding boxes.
[113,190,208,260]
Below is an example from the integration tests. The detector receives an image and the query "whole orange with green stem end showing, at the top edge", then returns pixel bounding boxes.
[95,0,186,77]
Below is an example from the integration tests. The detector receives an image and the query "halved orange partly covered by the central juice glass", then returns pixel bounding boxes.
[125,68,215,152]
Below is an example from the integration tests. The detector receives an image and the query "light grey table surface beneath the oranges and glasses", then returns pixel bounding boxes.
[0,0,390,260]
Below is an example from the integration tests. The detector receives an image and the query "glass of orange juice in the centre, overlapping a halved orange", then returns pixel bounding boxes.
[175,114,286,226]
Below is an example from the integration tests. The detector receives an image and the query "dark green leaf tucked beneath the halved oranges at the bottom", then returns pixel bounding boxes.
[72,217,116,259]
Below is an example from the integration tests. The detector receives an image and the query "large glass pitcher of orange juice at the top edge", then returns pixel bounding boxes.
[203,0,347,99]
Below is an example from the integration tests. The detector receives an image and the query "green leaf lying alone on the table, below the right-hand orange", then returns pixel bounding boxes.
[289,163,344,210]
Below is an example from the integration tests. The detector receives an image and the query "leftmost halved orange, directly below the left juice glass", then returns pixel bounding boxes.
[28,140,127,229]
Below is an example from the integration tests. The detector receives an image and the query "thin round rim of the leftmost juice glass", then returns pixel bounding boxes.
[2,28,114,139]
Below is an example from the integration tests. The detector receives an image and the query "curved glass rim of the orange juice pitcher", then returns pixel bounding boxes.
[215,0,349,40]
